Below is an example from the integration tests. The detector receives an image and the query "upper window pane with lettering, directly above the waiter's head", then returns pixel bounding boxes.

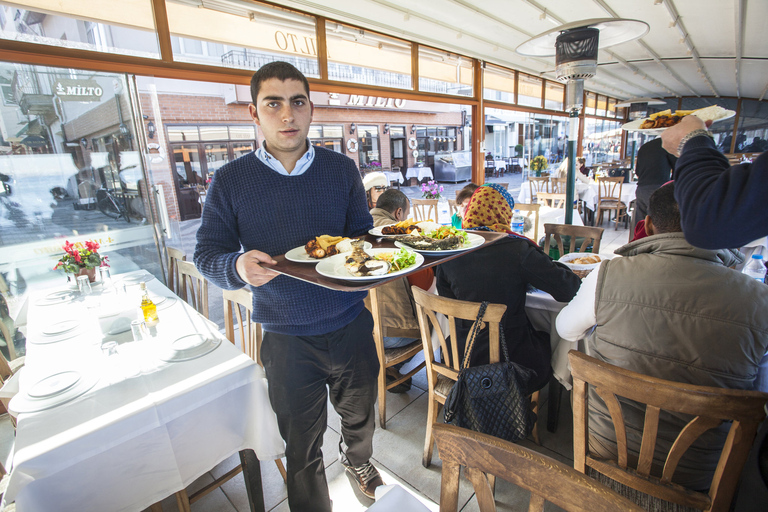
[165,0,320,78]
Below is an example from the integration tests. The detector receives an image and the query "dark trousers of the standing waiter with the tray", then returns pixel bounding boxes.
[261,309,379,512]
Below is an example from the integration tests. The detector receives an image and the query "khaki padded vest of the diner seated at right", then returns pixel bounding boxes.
[586,233,768,490]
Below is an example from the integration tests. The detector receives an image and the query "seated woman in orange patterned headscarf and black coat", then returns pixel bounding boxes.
[435,183,581,391]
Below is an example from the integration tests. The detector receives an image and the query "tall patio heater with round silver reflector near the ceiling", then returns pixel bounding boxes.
[517,18,648,224]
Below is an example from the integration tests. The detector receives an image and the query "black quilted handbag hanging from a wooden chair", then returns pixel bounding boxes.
[444,302,536,441]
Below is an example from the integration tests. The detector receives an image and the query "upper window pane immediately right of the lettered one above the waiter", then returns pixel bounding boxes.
[325,21,412,89]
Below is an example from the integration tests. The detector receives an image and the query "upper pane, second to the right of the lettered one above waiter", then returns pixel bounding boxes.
[419,46,474,96]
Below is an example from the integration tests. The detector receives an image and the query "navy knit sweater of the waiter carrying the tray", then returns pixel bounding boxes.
[194,148,373,336]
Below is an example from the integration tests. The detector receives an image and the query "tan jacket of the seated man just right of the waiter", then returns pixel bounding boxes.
[365,208,419,337]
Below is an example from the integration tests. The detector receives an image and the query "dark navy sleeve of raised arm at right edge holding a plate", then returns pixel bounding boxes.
[675,136,768,249]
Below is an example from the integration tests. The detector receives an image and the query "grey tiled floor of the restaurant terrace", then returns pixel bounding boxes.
[158,174,629,512]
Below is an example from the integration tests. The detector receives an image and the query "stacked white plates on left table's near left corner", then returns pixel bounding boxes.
[8,370,99,413]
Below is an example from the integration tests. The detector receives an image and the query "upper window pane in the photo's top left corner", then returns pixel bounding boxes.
[0,0,160,59]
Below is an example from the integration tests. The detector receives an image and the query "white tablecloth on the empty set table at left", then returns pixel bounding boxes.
[5,279,284,512]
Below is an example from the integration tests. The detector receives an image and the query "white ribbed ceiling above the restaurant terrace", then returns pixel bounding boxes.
[276,0,768,99]
